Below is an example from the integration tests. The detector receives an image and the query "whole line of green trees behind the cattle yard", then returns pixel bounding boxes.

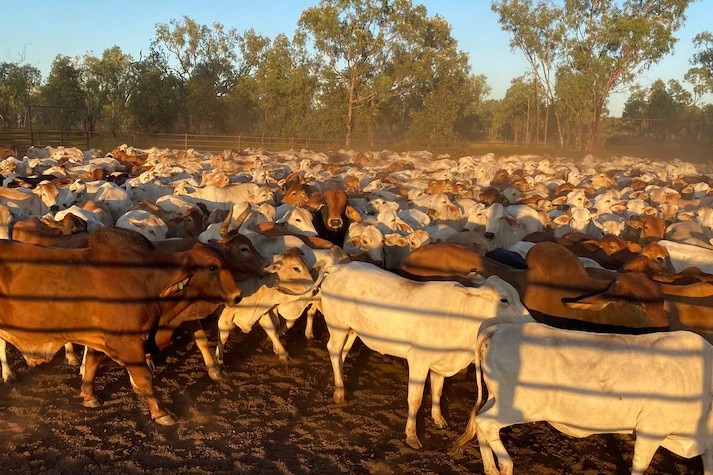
[0,0,713,149]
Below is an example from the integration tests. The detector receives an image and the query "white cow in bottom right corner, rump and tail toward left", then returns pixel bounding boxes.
[454,323,713,475]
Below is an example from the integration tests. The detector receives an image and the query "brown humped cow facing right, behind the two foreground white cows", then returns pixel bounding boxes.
[402,242,669,331]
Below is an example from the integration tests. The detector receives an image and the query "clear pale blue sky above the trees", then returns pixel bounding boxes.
[0,0,713,116]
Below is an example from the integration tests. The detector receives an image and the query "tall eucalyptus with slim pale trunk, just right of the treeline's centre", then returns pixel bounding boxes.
[298,0,467,146]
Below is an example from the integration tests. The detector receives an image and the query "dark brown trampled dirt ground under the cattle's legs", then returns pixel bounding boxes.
[0,319,702,475]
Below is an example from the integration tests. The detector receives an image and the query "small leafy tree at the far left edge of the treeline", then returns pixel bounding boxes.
[0,62,42,128]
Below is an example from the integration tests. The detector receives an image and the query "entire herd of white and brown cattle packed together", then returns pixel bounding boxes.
[0,145,713,474]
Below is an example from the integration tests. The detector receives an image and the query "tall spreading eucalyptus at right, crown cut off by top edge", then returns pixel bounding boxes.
[493,0,692,148]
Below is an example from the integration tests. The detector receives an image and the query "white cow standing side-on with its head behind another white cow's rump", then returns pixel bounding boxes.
[320,262,532,448]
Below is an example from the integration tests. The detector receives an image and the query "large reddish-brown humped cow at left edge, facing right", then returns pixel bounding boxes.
[0,228,240,425]
